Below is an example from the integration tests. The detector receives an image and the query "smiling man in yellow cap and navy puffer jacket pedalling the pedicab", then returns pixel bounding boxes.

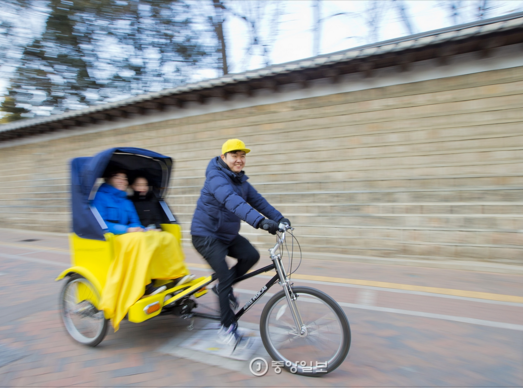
[191,139,290,347]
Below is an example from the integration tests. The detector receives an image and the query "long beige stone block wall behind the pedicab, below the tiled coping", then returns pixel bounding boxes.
[0,67,523,264]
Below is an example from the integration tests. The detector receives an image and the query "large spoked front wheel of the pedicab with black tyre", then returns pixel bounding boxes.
[260,287,351,376]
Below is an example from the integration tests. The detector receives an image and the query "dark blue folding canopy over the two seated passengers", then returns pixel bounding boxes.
[71,147,173,240]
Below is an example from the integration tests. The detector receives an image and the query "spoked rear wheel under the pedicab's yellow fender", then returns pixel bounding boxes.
[60,275,109,347]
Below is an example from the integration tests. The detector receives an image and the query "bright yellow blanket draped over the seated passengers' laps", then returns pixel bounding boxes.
[99,231,189,331]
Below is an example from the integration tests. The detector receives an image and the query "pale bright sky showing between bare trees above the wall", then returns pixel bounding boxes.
[0,0,523,112]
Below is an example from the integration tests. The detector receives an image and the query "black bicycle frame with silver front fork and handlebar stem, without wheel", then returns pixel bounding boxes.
[192,224,307,336]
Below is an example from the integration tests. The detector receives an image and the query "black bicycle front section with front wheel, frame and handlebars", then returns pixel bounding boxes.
[191,224,351,376]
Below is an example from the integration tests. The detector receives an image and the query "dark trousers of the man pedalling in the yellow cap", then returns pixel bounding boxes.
[192,235,260,326]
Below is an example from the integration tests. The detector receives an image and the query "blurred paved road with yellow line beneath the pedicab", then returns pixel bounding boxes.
[0,230,523,387]
